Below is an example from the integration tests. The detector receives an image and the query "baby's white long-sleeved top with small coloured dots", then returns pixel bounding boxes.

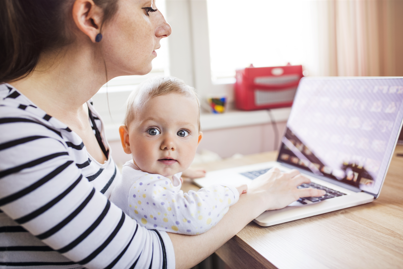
[128,175,239,235]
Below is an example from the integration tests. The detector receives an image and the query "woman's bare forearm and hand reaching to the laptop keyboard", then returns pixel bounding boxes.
[169,169,324,268]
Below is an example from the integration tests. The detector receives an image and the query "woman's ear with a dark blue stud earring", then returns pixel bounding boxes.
[73,0,104,43]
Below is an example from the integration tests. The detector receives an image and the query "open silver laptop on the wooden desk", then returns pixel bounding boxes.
[195,77,403,226]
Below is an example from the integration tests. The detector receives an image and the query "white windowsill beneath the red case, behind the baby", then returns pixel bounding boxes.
[105,107,291,141]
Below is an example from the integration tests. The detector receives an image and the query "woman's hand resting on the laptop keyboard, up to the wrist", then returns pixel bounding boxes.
[248,168,326,210]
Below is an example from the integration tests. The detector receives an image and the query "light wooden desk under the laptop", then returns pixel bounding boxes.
[184,146,403,269]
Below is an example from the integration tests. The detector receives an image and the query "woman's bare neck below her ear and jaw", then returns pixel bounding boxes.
[10,42,106,121]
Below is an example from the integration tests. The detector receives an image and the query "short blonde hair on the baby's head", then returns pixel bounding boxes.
[124,77,200,130]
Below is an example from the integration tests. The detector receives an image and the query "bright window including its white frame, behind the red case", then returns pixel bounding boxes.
[168,0,321,103]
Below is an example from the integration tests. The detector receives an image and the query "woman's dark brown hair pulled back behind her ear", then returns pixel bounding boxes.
[0,0,118,83]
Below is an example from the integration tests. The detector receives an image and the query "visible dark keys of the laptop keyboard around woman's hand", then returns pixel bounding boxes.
[240,168,346,205]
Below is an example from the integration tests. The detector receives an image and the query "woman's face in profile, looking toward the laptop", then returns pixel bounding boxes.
[101,0,171,78]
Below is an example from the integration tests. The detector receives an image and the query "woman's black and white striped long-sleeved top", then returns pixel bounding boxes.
[0,84,175,268]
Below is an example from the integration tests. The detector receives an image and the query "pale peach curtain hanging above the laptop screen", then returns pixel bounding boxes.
[317,0,403,76]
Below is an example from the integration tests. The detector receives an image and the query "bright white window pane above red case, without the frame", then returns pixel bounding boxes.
[207,0,316,81]
